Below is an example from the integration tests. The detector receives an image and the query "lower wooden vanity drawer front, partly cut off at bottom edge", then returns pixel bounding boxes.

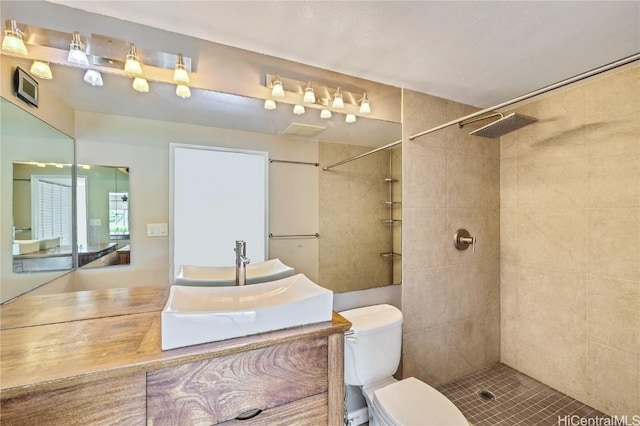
[219,393,329,426]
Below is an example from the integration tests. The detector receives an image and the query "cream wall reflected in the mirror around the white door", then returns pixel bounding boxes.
[75,111,318,290]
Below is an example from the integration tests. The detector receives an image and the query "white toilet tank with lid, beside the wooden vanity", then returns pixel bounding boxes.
[340,305,402,386]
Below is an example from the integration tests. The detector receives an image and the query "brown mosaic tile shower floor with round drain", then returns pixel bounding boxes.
[438,364,615,426]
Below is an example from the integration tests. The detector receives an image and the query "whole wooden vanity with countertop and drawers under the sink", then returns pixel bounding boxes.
[0,287,351,426]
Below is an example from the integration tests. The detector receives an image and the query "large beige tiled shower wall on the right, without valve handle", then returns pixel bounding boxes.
[501,67,640,414]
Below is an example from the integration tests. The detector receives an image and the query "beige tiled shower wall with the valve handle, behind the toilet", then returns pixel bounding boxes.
[402,90,500,385]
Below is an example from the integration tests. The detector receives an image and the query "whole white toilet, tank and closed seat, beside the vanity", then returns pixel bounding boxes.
[340,305,469,426]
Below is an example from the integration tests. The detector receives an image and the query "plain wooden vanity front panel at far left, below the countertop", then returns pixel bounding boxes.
[0,373,146,426]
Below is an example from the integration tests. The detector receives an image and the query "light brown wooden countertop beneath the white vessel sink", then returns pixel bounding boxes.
[0,286,351,399]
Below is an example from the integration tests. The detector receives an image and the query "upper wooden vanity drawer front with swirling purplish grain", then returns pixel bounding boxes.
[147,337,328,425]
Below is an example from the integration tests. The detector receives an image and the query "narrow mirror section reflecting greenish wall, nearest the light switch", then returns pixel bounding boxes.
[76,164,131,268]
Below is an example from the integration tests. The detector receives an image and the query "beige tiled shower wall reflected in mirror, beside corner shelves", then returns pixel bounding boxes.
[318,142,401,292]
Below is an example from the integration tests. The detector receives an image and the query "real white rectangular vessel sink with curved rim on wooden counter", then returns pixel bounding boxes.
[161,274,333,350]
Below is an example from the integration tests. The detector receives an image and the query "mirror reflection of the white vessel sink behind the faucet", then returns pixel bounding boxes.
[175,259,295,286]
